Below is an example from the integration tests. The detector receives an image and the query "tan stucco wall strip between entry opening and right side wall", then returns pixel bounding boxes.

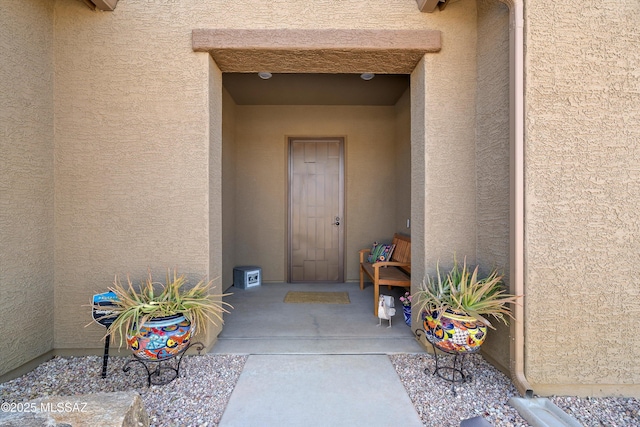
[411,1,477,329]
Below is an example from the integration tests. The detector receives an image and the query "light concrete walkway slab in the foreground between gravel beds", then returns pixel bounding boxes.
[220,355,422,427]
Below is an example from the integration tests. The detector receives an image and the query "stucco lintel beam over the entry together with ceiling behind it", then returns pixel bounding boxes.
[192,29,442,105]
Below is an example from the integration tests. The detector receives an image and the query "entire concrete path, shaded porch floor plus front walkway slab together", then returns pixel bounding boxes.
[212,283,424,427]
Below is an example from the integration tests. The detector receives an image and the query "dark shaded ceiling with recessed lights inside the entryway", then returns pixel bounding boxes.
[222,73,409,105]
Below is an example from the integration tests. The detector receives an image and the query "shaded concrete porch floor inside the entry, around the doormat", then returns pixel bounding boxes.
[211,283,424,354]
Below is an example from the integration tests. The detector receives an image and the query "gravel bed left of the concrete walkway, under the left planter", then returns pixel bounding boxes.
[0,355,247,427]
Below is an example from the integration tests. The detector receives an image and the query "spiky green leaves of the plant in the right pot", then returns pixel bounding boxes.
[414,257,520,329]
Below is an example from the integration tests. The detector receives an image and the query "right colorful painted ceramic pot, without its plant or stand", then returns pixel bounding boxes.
[422,312,487,353]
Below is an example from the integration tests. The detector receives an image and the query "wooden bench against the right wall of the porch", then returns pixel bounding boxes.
[359,233,411,316]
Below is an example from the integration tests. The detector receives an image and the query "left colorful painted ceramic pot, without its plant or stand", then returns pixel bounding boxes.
[127,315,195,360]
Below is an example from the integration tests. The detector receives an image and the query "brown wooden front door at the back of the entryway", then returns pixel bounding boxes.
[289,138,345,282]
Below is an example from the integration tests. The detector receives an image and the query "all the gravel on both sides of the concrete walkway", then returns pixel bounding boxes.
[0,354,640,427]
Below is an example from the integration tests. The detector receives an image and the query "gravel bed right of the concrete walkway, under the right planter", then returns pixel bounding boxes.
[390,354,640,427]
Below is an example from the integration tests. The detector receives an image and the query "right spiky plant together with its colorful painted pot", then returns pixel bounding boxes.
[414,257,519,353]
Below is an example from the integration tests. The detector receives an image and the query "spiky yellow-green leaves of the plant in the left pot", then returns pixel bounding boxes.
[99,269,233,346]
